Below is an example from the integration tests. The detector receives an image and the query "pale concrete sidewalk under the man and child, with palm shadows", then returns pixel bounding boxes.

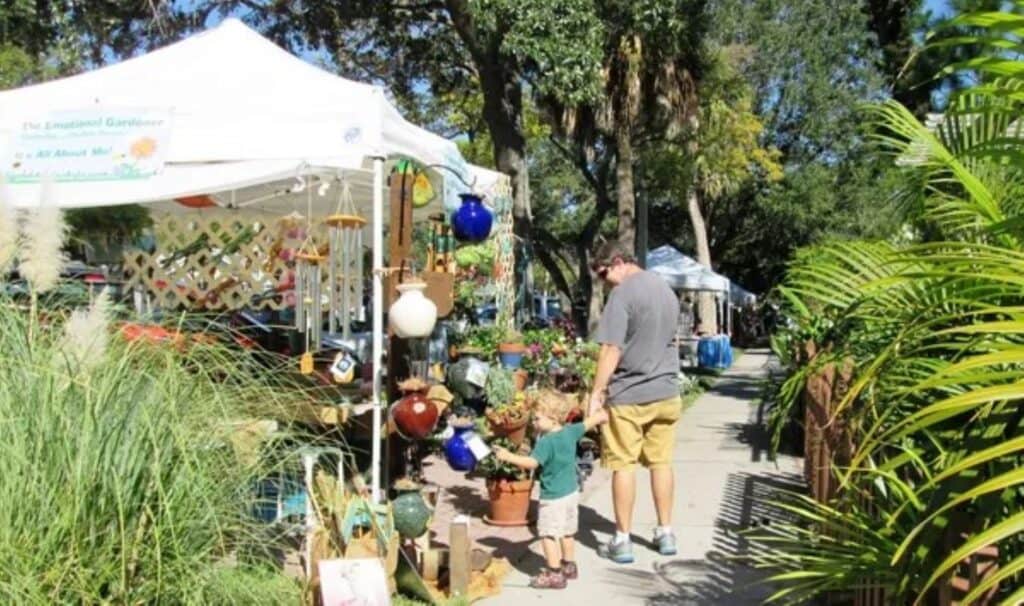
[482,350,803,606]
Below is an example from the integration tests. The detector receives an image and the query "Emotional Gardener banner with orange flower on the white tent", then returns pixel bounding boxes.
[3,107,171,183]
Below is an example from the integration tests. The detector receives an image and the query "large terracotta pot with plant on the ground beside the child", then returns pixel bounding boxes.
[476,438,534,526]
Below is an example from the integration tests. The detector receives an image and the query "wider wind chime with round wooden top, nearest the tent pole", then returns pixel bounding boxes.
[325,180,367,339]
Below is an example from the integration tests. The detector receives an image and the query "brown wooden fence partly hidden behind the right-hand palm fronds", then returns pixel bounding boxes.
[801,343,998,606]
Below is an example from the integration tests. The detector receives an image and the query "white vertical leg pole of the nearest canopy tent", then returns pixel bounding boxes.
[371,158,384,503]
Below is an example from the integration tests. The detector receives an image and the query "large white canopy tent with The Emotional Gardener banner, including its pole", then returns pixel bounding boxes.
[0,19,498,500]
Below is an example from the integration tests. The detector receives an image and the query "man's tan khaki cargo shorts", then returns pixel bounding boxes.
[601,396,683,471]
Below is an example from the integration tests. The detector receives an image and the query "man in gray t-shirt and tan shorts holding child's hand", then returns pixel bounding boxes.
[589,243,682,564]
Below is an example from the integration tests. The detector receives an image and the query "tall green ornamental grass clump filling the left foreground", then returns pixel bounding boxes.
[0,301,300,605]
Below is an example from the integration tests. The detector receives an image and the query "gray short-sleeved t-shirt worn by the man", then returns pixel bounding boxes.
[595,271,679,404]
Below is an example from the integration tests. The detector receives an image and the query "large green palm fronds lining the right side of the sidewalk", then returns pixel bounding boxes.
[751,7,1024,604]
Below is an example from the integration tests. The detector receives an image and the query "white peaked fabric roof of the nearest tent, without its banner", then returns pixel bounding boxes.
[0,18,469,208]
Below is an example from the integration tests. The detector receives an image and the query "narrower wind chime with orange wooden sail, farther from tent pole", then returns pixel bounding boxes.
[295,176,324,375]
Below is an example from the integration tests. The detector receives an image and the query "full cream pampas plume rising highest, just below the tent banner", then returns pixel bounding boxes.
[17,182,68,293]
